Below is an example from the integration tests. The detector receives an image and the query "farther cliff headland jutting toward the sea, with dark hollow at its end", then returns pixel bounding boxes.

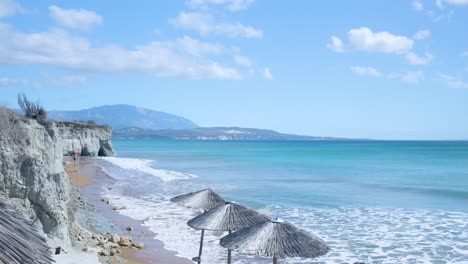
[44,122,114,157]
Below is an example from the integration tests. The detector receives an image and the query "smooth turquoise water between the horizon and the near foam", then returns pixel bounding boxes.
[114,140,468,211]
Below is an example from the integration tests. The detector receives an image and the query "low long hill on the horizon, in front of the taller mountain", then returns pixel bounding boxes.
[112,127,346,141]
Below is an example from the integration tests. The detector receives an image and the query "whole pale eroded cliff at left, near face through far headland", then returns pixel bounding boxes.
[0,116,113,242]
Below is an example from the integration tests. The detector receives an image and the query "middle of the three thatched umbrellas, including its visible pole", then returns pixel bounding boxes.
[187,202,270,264]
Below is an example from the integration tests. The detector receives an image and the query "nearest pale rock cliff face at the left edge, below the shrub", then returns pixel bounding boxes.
[0,120,69,241]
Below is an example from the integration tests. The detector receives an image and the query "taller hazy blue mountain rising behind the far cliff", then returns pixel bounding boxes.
[47,104,198,130]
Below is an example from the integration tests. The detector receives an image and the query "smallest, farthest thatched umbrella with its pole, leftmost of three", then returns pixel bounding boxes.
[171,189,224,263]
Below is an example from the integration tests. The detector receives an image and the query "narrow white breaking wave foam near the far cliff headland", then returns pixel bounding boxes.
[101,157,197,182]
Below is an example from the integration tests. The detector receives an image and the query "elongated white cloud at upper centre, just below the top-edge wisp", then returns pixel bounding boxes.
[169,12,263,38]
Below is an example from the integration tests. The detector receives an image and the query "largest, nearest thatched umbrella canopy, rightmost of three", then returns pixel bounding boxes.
[220,219,330,264]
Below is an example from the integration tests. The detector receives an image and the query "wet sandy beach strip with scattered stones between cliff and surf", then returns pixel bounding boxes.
[65,158,192,264]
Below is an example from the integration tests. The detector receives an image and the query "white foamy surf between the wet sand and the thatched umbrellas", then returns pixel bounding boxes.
[104,189,271,264]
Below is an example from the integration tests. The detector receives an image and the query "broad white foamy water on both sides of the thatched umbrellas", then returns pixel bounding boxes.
[105,188,468,263]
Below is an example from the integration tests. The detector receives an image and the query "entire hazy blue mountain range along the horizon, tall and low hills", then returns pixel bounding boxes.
[48,104,350,140]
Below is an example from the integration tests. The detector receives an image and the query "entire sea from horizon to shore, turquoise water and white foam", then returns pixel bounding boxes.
[98,140,468,264]
